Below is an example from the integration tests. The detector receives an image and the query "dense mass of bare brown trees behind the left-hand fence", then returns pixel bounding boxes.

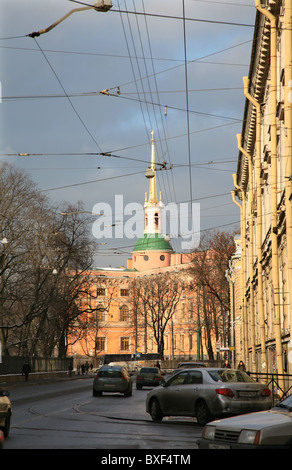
[0,164,95,356]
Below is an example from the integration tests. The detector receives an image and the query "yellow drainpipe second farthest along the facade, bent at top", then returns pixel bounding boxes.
[236,134,256,372]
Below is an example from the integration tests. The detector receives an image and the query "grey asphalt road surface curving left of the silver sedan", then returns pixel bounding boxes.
[5,376,202,451]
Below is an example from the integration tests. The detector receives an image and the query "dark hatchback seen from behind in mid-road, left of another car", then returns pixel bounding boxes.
[93,365,132,397]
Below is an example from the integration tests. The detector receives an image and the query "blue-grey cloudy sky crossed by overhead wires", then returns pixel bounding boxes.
[0,0,256,267]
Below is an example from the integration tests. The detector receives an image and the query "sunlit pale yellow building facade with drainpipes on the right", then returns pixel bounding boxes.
[228,0,292,374]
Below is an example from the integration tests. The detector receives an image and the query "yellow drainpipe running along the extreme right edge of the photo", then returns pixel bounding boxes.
[284,0,292,356]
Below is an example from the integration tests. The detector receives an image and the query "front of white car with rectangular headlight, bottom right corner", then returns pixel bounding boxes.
[198,395,292,450]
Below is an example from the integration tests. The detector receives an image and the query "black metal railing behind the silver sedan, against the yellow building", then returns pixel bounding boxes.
[249,372,292,404]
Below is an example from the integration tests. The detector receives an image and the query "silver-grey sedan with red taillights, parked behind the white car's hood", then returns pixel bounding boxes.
[146,367,272,425]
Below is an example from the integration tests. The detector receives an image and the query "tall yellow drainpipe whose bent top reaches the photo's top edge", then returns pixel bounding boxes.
[255,0,284,374]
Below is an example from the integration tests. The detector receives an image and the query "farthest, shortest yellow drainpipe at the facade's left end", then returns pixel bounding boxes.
[231,187,248,364]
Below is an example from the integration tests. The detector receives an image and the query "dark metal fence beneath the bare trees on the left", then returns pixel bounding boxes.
[0,356,72,375]
